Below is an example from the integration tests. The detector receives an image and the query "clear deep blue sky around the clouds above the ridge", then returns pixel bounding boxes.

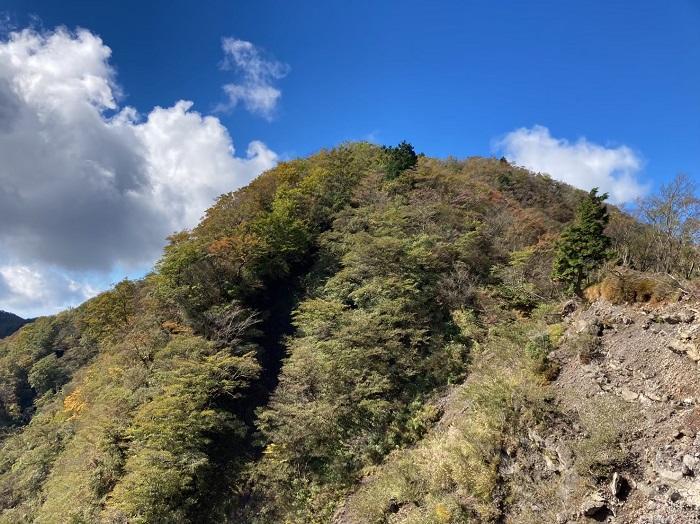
[4,0,700,178]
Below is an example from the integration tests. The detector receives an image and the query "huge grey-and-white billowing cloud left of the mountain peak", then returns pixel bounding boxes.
[0,29,277,314]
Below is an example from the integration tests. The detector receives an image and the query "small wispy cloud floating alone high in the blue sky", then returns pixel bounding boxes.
[219,38,289,119]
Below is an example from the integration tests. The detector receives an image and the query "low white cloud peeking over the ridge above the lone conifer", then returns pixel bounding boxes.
[494,126,647,203]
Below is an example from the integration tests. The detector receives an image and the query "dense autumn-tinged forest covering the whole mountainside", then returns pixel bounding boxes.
[0,143,698,524]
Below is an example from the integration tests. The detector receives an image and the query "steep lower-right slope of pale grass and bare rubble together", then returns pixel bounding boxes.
[334,280,700,524]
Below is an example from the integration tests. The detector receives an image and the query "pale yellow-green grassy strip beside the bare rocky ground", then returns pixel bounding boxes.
[345,318,546,524]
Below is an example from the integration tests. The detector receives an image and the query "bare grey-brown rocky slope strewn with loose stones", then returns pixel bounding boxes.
[535,300,700,524]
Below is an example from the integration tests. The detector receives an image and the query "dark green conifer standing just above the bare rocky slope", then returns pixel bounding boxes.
[552,188,611,295]
